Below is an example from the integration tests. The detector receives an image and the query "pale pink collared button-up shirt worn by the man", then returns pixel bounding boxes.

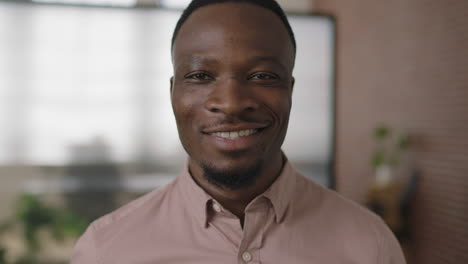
[71,163,405,264]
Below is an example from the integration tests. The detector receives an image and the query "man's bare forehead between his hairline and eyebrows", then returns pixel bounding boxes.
[173,2,294,69]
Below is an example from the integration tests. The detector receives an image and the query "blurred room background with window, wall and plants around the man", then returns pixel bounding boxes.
[0,0,468,264]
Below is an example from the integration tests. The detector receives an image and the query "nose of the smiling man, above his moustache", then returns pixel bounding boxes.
[205,79,258,115]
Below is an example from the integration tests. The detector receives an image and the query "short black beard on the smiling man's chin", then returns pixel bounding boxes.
[201,161,262,190]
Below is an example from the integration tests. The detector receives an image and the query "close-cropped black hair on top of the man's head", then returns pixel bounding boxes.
[171,0,296,51]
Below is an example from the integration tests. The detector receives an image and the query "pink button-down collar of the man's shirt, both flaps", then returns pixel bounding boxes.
[178,160,296,228]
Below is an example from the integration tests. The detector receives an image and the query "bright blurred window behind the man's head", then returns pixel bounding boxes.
[0,1,334,188]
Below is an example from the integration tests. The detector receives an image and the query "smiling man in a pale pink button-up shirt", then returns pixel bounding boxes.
[72,0,405,264]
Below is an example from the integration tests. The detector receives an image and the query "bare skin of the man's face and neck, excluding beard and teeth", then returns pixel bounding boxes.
[171,3,295,225]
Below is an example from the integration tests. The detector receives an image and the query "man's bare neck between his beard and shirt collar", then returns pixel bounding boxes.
[189,152,284,222]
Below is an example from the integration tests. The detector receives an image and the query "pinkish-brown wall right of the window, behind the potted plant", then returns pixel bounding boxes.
[314,0,468,264]
